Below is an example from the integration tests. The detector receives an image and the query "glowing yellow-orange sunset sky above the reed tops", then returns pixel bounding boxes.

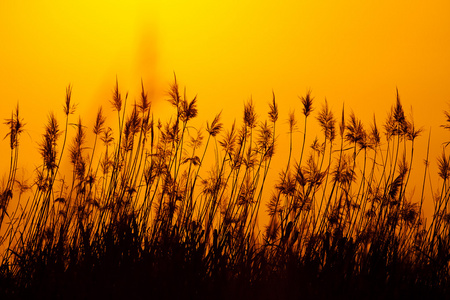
[0,0,450,216]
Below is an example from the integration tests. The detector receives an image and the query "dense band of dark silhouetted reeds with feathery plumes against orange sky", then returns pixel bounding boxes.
[0,80,450,299]
